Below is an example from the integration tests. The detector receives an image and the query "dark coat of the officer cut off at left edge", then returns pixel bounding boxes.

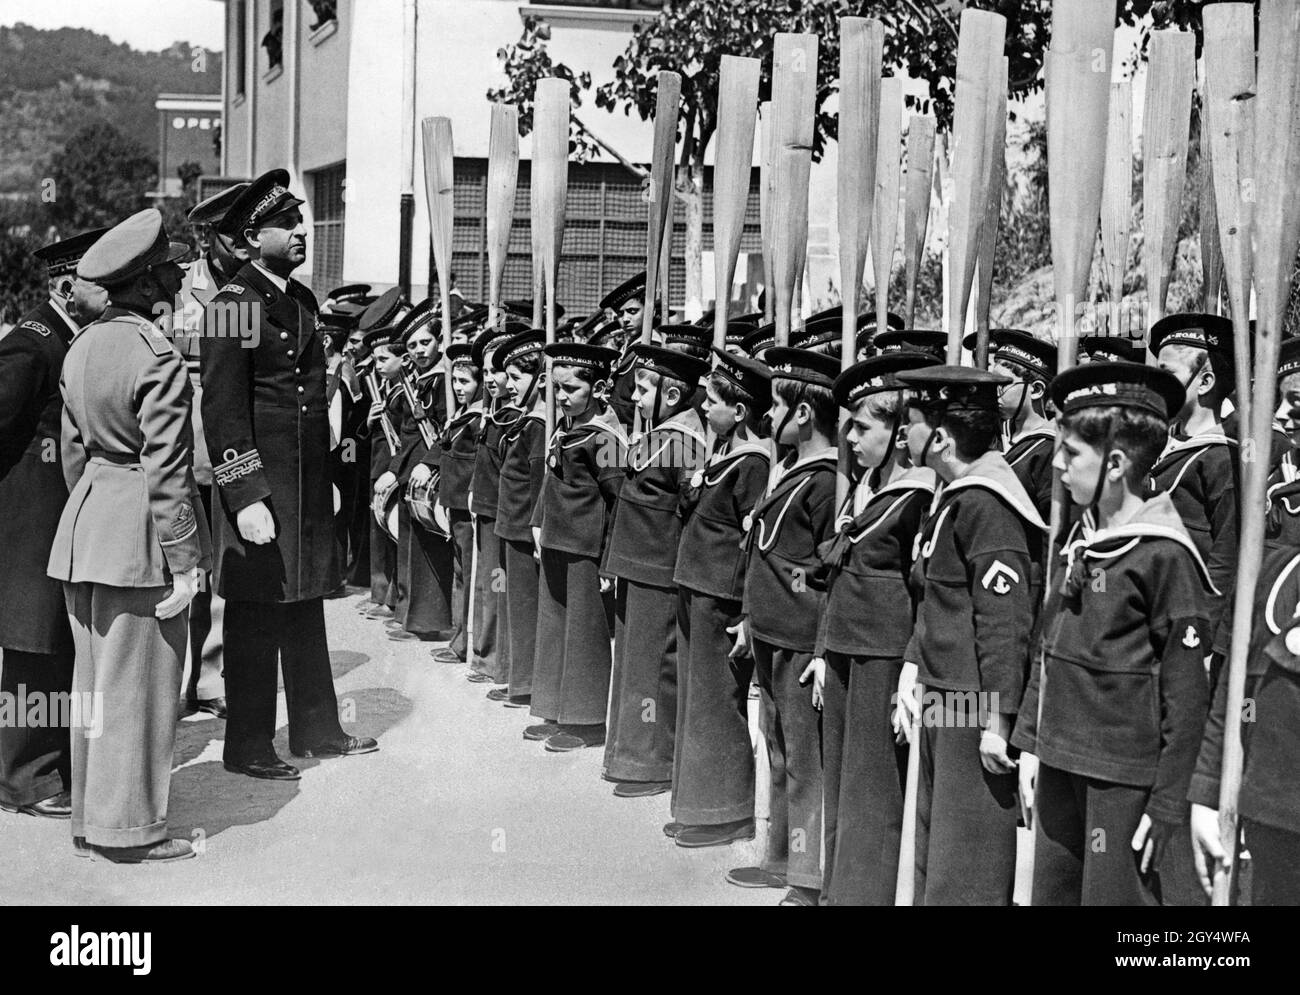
[0,300,75,653]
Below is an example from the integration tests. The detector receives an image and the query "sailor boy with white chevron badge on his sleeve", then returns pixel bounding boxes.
[894,365,1048,905]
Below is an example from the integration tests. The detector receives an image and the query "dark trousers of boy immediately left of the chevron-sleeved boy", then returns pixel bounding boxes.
[822,653,907,905]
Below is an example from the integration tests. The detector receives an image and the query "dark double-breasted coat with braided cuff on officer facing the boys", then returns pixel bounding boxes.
[200,263,341,604]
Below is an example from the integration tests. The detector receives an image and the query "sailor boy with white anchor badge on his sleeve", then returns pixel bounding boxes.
[1011,363,1213,905]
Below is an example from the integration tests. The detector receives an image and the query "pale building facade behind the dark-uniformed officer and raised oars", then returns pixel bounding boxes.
[220,0,828,311]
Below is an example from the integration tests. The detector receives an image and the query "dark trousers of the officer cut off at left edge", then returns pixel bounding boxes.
[0,649,72,806]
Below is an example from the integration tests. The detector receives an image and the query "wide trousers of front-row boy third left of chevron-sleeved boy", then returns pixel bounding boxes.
[672,588,754,826]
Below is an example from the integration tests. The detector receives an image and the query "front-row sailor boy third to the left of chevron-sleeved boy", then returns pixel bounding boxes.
[664,349,772,848]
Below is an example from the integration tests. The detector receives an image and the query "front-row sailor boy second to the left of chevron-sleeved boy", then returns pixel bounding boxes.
[727,347,840,905]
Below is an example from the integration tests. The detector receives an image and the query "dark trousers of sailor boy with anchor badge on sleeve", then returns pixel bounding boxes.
[1031,763,1164,905]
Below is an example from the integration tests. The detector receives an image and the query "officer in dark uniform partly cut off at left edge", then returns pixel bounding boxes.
[0,228,107,818]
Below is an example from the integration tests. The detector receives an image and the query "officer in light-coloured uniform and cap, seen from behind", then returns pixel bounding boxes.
[49,208,211,864]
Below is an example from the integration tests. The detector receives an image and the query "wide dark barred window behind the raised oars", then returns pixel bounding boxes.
[429,159,761,315]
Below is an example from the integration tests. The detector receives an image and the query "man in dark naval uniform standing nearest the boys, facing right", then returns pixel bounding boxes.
[200,169,378,780]
